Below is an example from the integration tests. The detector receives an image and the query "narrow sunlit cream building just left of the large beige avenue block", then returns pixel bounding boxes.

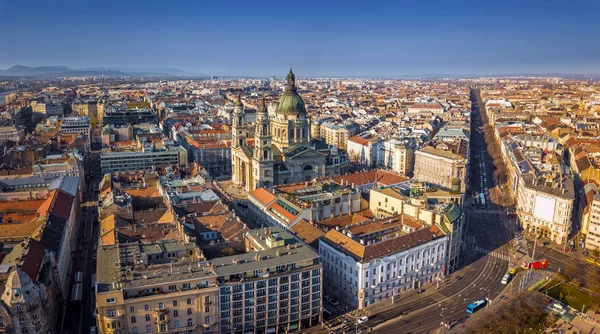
[382,139,415,175]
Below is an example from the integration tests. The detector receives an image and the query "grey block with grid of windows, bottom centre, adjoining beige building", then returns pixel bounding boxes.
[212,228,322,334]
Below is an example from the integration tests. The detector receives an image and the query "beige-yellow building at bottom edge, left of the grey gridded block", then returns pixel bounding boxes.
[96,241,219,334]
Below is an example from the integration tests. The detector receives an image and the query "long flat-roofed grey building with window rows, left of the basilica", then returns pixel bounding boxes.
[100,143,188,173]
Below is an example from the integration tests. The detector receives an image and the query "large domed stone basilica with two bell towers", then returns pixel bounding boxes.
[231,69,349,191]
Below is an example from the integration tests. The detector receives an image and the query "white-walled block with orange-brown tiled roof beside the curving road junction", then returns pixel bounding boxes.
[319,223,448,309]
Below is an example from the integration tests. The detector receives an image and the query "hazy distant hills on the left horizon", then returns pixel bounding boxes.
[0,65,198,77]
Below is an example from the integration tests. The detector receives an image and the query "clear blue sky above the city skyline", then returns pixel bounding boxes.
[0,0,600,76]
